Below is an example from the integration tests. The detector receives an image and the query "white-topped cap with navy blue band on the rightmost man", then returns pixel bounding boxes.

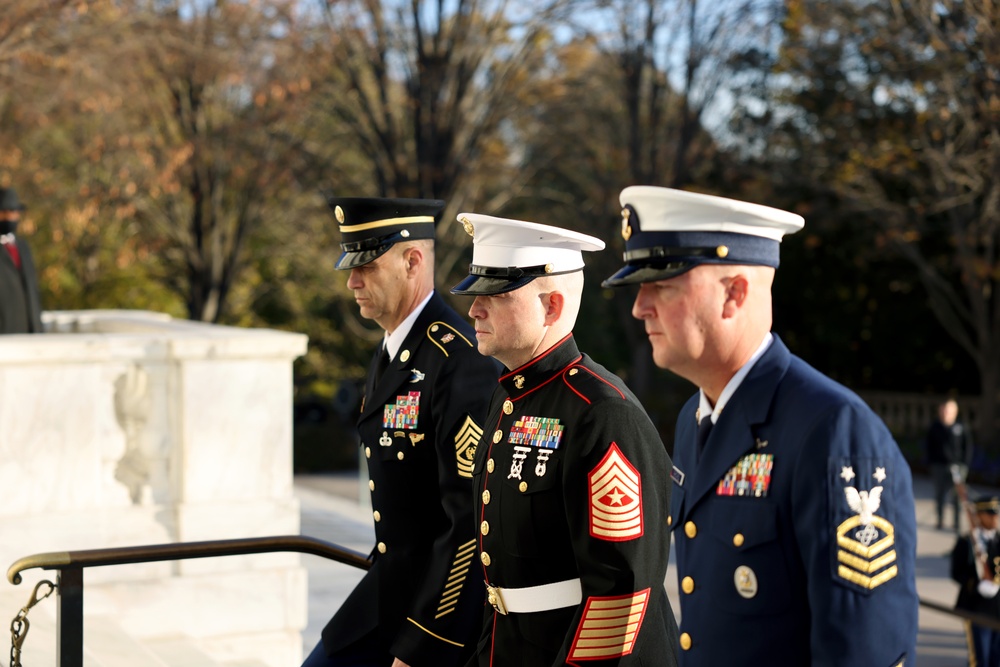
[602,185,804,287]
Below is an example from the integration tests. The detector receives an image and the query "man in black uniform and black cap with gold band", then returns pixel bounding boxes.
[304,197,499,667]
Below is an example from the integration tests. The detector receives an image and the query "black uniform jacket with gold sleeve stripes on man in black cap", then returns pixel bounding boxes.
[323,293,498,667]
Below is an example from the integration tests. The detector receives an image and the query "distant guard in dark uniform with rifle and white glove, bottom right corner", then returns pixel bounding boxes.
[951,497,1000,667]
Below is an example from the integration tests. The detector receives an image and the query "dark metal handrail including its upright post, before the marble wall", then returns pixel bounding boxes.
[7,535,372,667]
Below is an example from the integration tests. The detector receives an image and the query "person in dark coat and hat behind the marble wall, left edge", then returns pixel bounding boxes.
[0,188,43,334]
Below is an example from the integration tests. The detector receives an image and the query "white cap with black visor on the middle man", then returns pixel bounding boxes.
[451,213,604,296]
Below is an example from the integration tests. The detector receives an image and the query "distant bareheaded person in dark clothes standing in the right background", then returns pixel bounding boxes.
[926,398,972,533]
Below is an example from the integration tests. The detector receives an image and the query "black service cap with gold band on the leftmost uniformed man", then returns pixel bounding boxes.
[326,196,444,269]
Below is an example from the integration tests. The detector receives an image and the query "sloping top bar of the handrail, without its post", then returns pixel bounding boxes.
[7,535,371,585]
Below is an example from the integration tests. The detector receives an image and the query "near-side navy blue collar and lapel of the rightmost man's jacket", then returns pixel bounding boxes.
[685,336,791,508]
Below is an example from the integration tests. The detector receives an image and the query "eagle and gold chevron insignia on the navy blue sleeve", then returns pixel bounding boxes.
[830,460,899,592]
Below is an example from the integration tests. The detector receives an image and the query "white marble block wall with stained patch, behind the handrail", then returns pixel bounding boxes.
[0,311,307,667]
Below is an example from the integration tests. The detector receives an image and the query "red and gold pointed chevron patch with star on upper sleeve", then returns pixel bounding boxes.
[588,442,643,542]
